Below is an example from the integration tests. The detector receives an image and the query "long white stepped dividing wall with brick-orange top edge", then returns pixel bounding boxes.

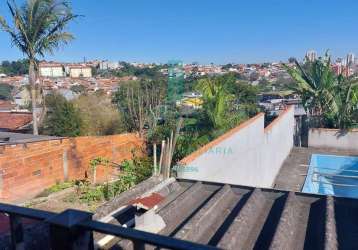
[176,108,294,187]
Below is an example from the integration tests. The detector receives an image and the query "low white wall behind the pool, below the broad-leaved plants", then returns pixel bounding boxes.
[308,128,358,151]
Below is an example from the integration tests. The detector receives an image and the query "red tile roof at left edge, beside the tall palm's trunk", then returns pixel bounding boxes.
[0,112,32,130]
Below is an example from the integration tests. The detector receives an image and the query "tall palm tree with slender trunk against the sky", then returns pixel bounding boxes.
[0,0,77,135]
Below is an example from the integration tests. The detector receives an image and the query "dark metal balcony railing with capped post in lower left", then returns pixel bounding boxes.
[0,203,217,250]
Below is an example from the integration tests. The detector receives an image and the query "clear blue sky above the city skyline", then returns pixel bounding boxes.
[0,0,358,64]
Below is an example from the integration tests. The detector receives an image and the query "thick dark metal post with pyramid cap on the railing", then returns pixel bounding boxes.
[48,209,94,250]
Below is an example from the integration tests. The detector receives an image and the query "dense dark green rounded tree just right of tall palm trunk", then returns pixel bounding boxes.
[44,94,82,137]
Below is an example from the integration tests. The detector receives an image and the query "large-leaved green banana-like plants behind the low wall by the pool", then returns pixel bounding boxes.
[284,53,358,129]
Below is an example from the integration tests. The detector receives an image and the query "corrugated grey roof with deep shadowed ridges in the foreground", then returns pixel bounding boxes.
[111,180,358,249]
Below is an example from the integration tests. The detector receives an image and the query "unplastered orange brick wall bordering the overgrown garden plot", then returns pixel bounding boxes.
[0,134,144,202]
